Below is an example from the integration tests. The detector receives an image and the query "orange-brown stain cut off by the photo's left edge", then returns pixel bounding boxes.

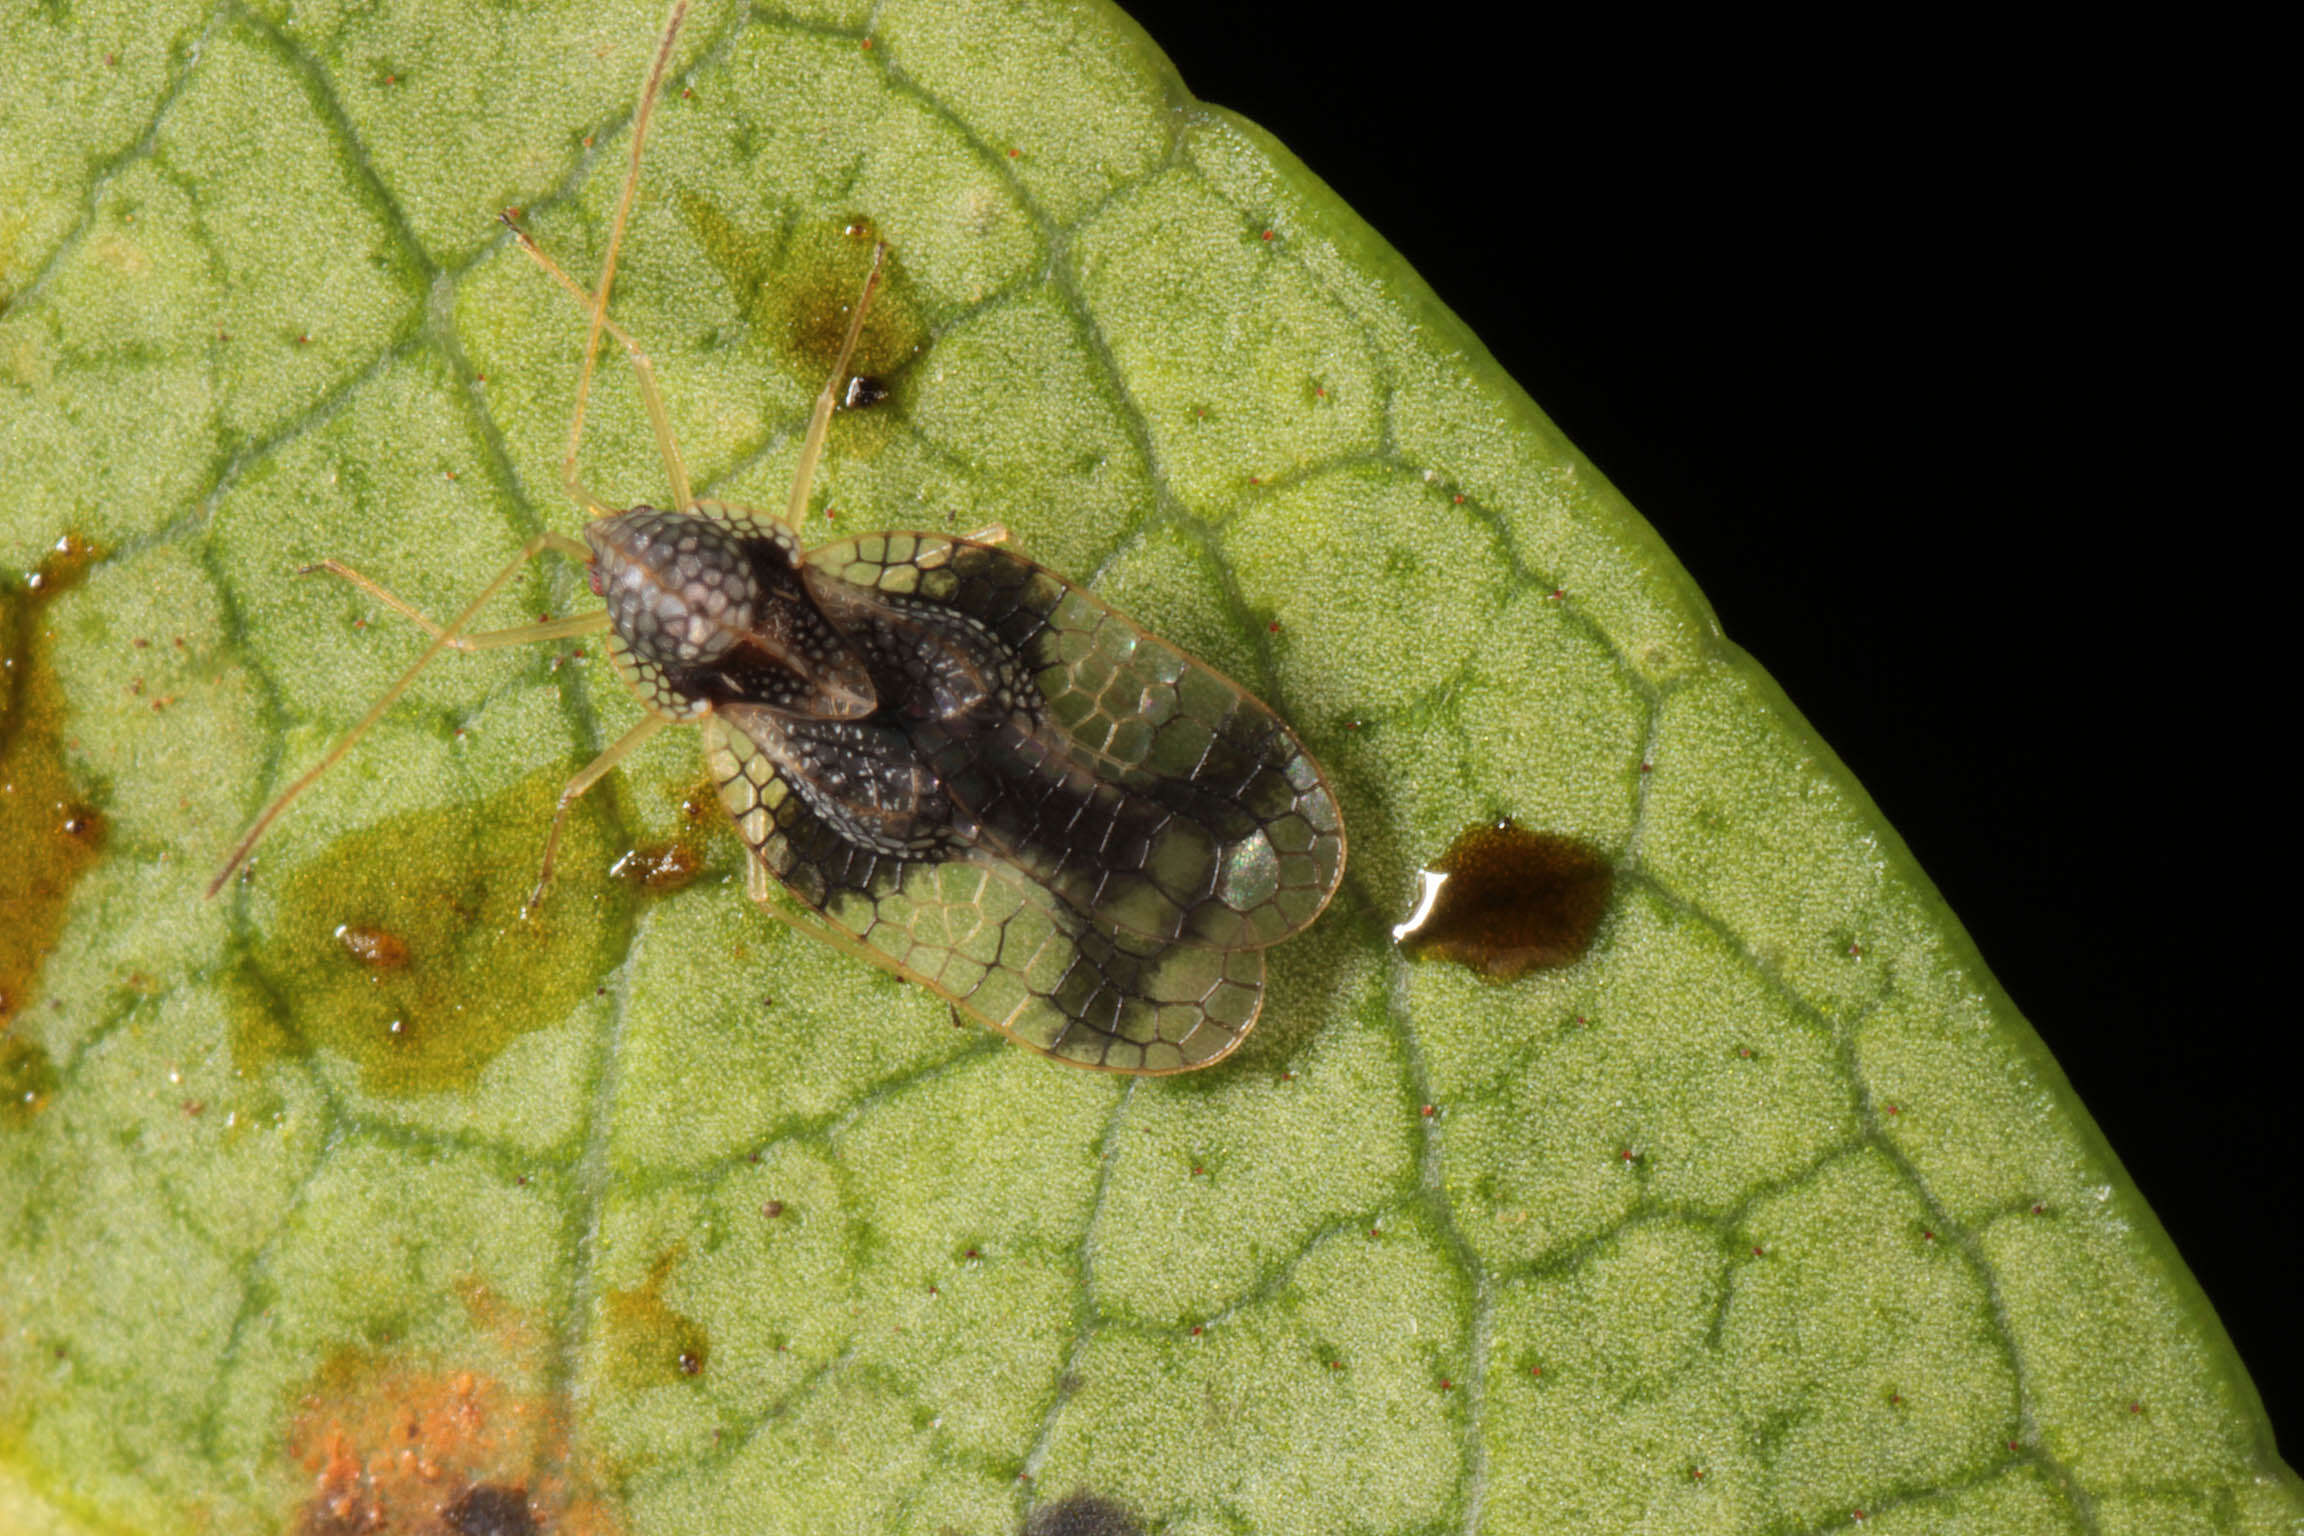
[0,537,104,1027]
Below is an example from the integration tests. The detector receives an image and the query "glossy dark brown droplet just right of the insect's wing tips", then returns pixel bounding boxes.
[1392,822,1615,981]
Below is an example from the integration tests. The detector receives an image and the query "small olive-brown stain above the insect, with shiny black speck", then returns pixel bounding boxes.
[680,191,929,396]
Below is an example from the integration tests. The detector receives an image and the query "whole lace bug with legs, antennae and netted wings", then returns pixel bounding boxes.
[210,0,1343,1073]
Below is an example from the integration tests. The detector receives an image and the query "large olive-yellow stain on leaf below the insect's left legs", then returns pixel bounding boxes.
[233,769,631,1096]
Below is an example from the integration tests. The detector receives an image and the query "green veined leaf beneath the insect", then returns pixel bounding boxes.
[0,2,2304,1534]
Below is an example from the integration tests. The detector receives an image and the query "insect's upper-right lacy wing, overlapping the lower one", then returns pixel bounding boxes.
[809,534,1343,949]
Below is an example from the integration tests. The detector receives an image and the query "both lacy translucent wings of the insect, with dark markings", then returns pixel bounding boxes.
[707,534,1343,1073]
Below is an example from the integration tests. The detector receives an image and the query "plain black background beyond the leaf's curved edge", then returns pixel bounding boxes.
[1129,2,2304,1453]
